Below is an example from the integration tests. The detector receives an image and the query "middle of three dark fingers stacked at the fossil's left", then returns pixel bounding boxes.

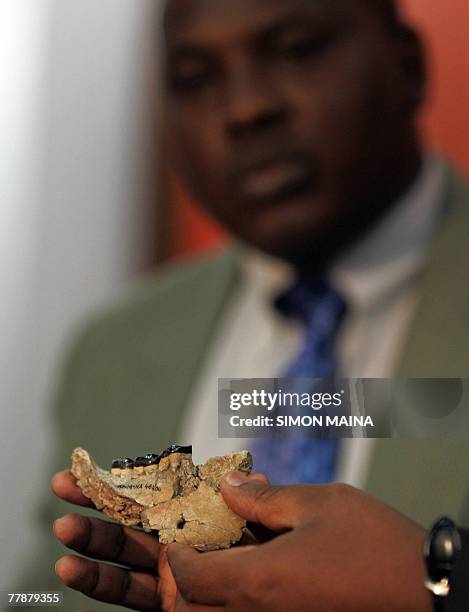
[53,514,161,572]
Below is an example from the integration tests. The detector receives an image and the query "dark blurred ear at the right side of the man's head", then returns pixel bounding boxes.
[395,24,428,112]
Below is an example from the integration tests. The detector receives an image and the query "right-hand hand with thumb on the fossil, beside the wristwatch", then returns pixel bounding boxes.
[168,472,432,612]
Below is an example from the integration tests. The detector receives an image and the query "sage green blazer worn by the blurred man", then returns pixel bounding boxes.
[23,163,469,610]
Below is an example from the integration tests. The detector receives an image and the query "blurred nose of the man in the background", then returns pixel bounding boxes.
[226,63,288,139]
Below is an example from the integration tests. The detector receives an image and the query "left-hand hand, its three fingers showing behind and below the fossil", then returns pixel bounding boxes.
[52,470,176,612]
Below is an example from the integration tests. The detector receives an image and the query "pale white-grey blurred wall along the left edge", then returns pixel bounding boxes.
[0,0,155,589]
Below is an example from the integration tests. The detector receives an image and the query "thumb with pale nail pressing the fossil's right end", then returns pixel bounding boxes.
[221,472,309,532]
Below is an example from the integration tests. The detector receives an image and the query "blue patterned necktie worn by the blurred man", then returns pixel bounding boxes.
[253,280,345,484]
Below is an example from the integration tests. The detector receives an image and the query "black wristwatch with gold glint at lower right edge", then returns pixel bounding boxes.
[424,517,462,612]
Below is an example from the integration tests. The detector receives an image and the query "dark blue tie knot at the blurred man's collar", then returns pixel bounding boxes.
[276,278,346,335]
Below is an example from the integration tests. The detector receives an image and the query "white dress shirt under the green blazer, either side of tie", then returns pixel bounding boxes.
[180,156,444,487]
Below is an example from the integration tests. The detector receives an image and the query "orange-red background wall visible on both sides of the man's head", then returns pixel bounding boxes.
[163,0,469,257]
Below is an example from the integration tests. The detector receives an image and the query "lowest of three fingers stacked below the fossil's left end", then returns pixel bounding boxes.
[55,555,160,611]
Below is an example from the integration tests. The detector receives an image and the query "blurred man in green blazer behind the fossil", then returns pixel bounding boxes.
[26,0,469,609]
